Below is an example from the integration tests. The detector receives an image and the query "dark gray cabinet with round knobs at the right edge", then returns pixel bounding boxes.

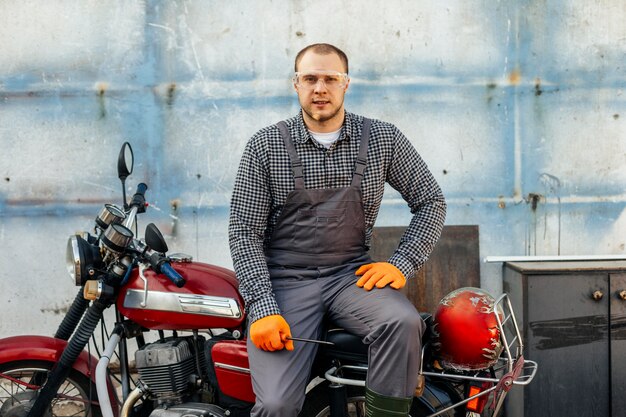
[504,261,626,417]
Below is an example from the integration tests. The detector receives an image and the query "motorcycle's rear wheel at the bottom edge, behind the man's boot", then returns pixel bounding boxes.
[298,381,464,417]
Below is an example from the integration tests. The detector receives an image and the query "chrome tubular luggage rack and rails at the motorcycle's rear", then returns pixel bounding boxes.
[324,294,538,417]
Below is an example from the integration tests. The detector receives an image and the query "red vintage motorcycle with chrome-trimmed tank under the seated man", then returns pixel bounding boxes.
[0,142,537,417]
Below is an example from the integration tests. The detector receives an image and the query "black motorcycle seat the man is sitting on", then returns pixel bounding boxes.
[323,313,433,363]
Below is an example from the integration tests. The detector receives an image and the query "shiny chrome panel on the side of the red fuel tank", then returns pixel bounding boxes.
[124,290,242,319]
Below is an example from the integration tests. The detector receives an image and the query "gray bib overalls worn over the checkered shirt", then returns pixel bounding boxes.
[248,119,425,417]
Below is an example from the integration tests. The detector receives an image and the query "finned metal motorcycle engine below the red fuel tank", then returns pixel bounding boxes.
[135,336,207,406]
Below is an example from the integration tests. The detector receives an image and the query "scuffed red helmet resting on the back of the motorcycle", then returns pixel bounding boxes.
[432,287,503,371]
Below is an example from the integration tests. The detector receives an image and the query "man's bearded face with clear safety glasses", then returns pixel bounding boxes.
[294,51,349,133]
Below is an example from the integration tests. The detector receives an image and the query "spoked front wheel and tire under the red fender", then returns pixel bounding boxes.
[0,360,102,417]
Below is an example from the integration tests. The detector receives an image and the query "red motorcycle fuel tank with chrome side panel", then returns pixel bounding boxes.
[117,262,244,330]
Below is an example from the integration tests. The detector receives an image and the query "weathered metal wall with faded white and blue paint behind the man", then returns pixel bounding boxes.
[0,0,626,337]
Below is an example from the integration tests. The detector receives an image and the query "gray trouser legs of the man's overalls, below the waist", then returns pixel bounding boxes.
[248,263,425,417]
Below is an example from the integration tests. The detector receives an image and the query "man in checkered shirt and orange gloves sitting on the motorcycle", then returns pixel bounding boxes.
[229,44,446,417]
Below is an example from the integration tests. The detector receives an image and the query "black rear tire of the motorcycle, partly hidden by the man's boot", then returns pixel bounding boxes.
[298,381,460,417]
